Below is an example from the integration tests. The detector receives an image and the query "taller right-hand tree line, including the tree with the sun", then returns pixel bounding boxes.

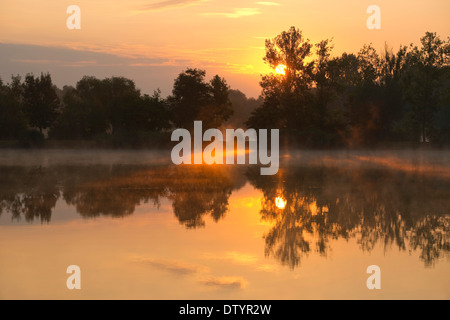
[247,27,450,147]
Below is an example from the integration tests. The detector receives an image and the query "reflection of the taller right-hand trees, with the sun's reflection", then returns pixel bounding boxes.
[247,166,450,268]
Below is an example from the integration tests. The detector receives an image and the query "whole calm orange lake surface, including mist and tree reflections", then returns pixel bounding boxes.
[0,150,450,299]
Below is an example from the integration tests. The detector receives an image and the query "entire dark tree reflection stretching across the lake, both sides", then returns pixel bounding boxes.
[0,158,450,268]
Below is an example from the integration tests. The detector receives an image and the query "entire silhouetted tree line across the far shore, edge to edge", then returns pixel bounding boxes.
[0,27,450,148]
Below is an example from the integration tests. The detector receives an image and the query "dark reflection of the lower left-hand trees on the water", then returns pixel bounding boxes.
[0,166,245,228]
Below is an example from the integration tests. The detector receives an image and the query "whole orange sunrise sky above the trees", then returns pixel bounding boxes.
[0,0,450,97]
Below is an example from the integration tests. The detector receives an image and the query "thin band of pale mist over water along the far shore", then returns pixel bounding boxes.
[0,149,450,170]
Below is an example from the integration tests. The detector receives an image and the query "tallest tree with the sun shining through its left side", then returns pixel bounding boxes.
[247,27,314,133]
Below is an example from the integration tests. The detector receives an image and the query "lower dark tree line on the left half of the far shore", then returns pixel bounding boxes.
[0,69,244,145]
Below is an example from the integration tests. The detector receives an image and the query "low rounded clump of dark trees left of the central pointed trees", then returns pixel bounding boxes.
[50,77,170,144]
